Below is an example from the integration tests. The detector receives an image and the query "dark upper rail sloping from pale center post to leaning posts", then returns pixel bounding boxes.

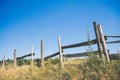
[62,39,97,49]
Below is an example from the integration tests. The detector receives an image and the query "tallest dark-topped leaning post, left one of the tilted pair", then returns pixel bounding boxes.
[93,22,104,60]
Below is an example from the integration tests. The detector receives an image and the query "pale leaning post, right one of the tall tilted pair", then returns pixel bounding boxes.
[98,25,110,62]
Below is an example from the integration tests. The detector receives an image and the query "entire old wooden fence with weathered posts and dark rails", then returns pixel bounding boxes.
[3,22,120,68]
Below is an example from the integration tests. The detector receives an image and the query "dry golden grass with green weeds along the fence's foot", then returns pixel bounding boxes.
[0,57,120,80]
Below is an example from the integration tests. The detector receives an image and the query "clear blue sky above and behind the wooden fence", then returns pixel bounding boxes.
[0,0,120,60]
